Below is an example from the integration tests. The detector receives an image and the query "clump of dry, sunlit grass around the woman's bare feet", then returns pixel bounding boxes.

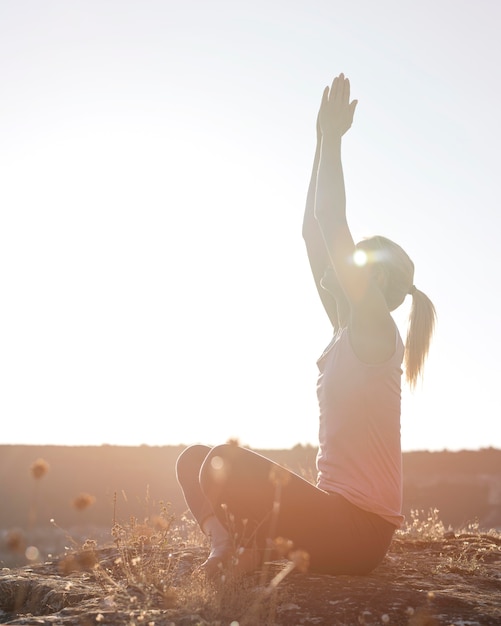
[47,504,300,626]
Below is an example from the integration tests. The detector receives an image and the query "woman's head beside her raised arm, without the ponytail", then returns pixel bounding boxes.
[357,235,414,311]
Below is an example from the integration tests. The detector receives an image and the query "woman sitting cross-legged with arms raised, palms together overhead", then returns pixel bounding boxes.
[176,74,435,574]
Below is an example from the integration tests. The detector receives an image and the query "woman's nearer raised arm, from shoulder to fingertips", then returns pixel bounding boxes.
[314,74,395,362]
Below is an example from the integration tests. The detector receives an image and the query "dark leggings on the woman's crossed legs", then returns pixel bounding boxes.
[176,444,395,574]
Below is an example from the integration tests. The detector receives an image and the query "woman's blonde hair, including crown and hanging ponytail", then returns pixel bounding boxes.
[357,235,437,388]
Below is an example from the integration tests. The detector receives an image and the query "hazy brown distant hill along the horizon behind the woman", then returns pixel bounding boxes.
[0,445,501,530]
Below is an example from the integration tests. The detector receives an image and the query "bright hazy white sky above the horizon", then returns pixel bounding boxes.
[0,0,501,450]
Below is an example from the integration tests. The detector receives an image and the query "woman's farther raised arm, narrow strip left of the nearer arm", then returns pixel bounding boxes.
[303,95,347,330]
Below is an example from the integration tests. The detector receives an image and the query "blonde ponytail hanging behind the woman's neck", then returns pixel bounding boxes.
[404,285,437,388]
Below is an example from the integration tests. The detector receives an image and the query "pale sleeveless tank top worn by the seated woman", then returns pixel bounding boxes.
[317,328,404,527]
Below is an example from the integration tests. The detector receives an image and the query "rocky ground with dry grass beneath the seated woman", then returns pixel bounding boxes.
[0,533,501,626]
